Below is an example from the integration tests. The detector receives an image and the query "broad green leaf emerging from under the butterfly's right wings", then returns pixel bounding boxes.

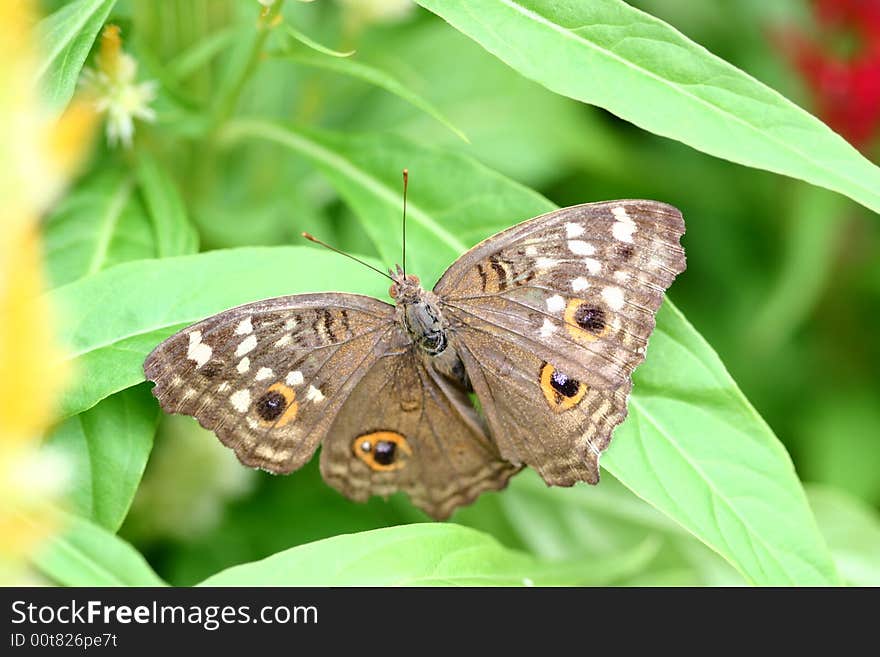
[602,303,838,585]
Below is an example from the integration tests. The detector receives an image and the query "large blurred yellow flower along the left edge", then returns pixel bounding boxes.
[0,2,95,579]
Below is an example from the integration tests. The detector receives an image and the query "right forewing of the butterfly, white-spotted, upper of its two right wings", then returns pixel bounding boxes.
[434,201,685,388]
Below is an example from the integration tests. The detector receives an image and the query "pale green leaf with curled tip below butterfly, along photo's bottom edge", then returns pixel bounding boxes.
[201,523,656,586]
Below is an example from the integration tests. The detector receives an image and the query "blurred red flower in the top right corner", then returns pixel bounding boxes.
[783,0,880,148]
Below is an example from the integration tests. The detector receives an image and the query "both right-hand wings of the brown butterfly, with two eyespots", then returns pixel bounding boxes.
[435,201,685,485]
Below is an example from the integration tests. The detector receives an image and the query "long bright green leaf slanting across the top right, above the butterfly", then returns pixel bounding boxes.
[418,0,880,212]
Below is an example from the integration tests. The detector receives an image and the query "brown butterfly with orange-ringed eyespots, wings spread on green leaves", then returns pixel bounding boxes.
[144,200,685,519]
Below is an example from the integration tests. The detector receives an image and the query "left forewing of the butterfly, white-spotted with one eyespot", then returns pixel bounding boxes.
[144,294,396,473]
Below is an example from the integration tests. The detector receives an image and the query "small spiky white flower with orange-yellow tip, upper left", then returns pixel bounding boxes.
[80,25,156,148]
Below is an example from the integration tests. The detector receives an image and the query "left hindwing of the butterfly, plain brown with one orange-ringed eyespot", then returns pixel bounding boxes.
[321,333,519,519]
